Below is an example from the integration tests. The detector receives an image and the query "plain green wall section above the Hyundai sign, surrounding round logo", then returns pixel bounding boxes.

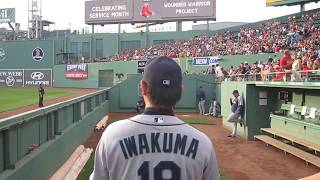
[0,40,54,69]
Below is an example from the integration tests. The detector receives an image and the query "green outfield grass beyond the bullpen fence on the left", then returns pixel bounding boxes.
[0,88,77,112]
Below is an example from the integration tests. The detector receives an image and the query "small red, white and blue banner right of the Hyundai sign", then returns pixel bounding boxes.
[65,64,88,79]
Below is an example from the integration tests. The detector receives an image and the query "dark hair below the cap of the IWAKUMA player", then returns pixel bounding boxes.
[148,86,182,108]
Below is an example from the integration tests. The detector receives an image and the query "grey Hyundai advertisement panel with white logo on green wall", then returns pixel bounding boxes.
[24,69,52,87]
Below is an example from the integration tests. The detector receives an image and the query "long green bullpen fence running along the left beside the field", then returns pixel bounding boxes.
[0,89,109,180]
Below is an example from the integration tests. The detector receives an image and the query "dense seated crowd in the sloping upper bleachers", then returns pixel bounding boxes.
[99,11,320,61]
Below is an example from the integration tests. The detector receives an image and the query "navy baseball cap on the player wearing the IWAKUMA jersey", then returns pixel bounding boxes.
[142,56,182,89]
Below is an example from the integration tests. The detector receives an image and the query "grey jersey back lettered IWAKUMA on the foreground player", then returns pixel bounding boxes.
[91,115,219,180]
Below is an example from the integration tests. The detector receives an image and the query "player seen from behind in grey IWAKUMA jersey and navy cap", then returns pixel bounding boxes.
[90,56,219,180]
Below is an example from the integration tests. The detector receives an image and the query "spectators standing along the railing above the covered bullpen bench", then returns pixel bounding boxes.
[214,50,320,81]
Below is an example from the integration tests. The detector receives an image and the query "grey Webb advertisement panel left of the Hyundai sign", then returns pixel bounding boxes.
[0,69,23,87]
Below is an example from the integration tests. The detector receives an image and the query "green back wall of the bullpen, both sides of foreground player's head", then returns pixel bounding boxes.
[109,75,219,112]
